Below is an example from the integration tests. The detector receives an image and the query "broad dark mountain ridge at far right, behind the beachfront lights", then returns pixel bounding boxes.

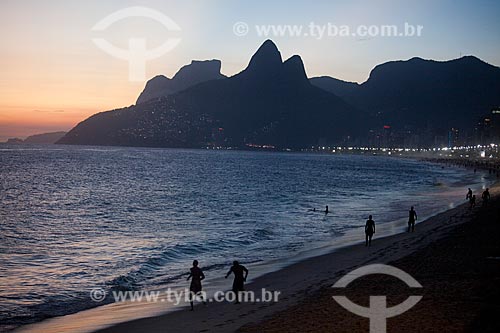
[311,56,500,131]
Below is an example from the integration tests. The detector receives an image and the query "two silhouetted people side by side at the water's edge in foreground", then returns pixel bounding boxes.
[187,260,248,311]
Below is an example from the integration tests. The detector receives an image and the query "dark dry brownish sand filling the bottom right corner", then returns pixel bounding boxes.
[244,187,500,333]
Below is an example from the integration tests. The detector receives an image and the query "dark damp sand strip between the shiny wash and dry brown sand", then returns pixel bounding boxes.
[14,185,492,332]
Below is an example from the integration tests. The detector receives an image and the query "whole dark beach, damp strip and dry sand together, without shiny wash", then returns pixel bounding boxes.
[57,187,500,332]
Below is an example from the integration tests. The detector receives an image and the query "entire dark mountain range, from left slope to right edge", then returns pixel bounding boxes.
[58,40,500,149]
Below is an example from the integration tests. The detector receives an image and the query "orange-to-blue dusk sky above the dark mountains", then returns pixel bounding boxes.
[0,0,500,141]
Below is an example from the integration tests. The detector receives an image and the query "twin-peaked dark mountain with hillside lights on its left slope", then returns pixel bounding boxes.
[59,40,371,149]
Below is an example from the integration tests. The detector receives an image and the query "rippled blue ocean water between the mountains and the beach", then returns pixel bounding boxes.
[0,145,489,330]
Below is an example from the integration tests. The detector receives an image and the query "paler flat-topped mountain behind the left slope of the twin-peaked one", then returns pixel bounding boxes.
[136,59,226,104]
